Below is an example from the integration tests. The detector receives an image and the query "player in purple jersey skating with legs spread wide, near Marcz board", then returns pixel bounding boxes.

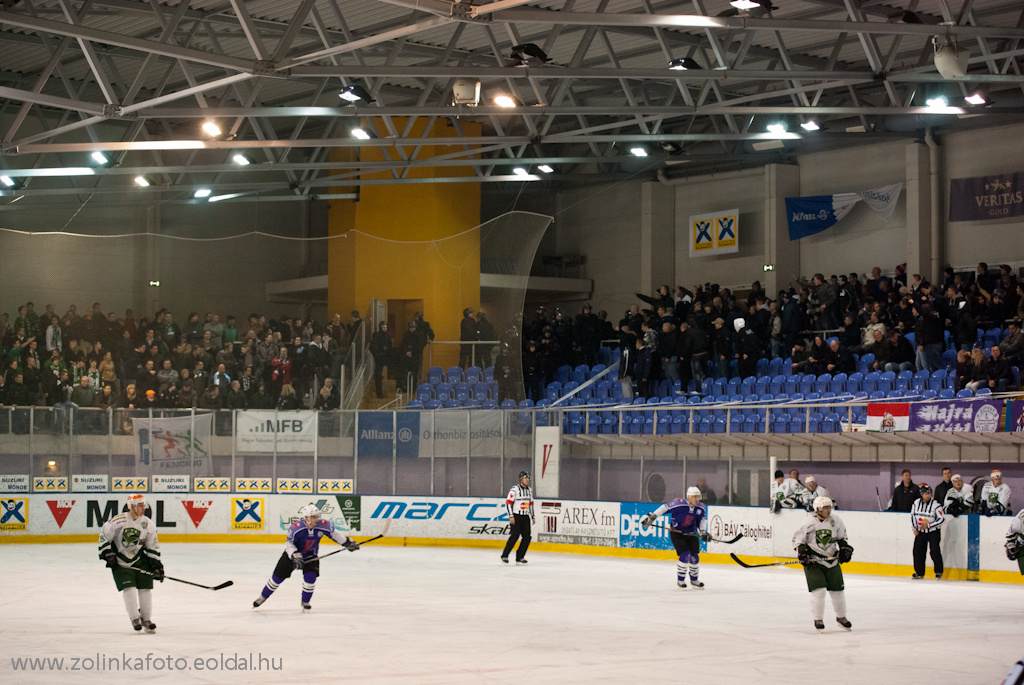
[253,505,359,613]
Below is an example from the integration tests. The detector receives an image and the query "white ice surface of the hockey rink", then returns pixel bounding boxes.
[0,544,1024,685]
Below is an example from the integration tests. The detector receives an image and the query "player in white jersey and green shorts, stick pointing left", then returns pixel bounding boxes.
[793,497,853,633]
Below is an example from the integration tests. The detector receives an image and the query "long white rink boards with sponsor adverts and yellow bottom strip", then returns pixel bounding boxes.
[0,493,1024,583]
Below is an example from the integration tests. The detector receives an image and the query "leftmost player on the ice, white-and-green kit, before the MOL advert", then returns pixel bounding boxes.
[99,494,164,633]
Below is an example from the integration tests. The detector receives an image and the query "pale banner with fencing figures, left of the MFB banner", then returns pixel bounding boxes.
[131,414,213,476]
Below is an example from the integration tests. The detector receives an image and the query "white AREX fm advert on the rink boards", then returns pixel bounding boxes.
[534,500,620,547]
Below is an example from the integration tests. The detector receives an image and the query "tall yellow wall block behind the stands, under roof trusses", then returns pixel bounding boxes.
[328,119,480,367]
